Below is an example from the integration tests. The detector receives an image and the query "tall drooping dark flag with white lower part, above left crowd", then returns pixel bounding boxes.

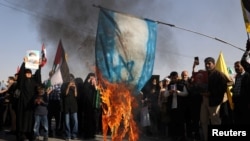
[51,40,70,85]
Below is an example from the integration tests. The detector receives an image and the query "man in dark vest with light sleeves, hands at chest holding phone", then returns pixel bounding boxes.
[165,71,188,141]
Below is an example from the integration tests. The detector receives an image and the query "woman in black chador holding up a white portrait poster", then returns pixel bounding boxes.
[16,57,41,141]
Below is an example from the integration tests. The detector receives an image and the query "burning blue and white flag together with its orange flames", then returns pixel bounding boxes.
[95,8,157,141]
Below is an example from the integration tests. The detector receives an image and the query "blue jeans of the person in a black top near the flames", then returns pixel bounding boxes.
[65,113,78,139]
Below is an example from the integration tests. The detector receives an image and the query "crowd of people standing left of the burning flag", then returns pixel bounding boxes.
[0,57,102,141]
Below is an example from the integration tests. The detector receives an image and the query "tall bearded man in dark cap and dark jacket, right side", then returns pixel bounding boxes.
[200,57,232,141]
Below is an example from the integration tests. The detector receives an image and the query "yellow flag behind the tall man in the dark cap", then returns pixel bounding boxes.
[215,52,234,110]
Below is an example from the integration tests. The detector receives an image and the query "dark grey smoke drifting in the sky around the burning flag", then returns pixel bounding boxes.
[19,0,176,77]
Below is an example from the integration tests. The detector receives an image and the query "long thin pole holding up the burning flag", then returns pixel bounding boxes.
[93,4,244,51]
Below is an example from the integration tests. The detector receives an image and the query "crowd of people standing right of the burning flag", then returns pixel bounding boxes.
[139,41,250,141]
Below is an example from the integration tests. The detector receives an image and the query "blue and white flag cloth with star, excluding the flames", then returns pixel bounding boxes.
[95,8,157,91]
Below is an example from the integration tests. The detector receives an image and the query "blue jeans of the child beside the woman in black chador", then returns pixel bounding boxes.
[33,115,48,137]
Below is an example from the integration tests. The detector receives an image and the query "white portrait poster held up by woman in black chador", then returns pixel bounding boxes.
[25,50,40,69]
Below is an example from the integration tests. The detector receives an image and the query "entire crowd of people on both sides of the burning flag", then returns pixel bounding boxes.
[0,41,250,141]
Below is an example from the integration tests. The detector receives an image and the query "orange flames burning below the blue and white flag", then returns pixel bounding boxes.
[99,77,139,141]
